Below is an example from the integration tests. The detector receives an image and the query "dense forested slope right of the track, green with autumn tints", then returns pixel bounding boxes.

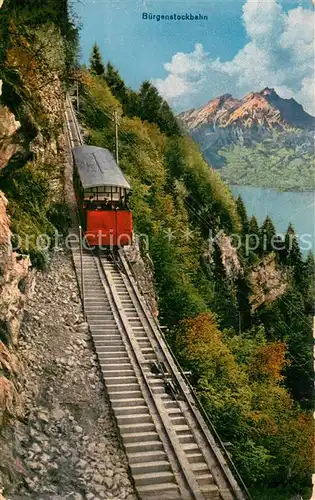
[83,45,314,499]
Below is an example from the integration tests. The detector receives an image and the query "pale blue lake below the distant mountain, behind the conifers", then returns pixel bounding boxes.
[230,186,315,254]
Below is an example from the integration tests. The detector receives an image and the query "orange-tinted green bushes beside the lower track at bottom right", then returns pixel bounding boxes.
[177,314,313,490]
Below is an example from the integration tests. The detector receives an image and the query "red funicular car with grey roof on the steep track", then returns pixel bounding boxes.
[72,146,133,247]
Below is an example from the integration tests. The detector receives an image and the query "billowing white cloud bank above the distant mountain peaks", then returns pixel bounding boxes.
[153,0,315,114]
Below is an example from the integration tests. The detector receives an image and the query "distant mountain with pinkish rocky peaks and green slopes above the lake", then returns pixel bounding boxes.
[178,87,315,190]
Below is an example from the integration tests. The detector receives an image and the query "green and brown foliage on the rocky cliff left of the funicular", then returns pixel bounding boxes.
[0,0,78,269]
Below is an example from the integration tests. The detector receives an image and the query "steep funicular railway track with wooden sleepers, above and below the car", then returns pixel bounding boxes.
[66,94,250,500]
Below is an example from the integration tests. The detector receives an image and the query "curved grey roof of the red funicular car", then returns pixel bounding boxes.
[72,146,131,189]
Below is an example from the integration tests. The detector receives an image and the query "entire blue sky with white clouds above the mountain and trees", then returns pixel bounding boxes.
[74,0,315,113]
